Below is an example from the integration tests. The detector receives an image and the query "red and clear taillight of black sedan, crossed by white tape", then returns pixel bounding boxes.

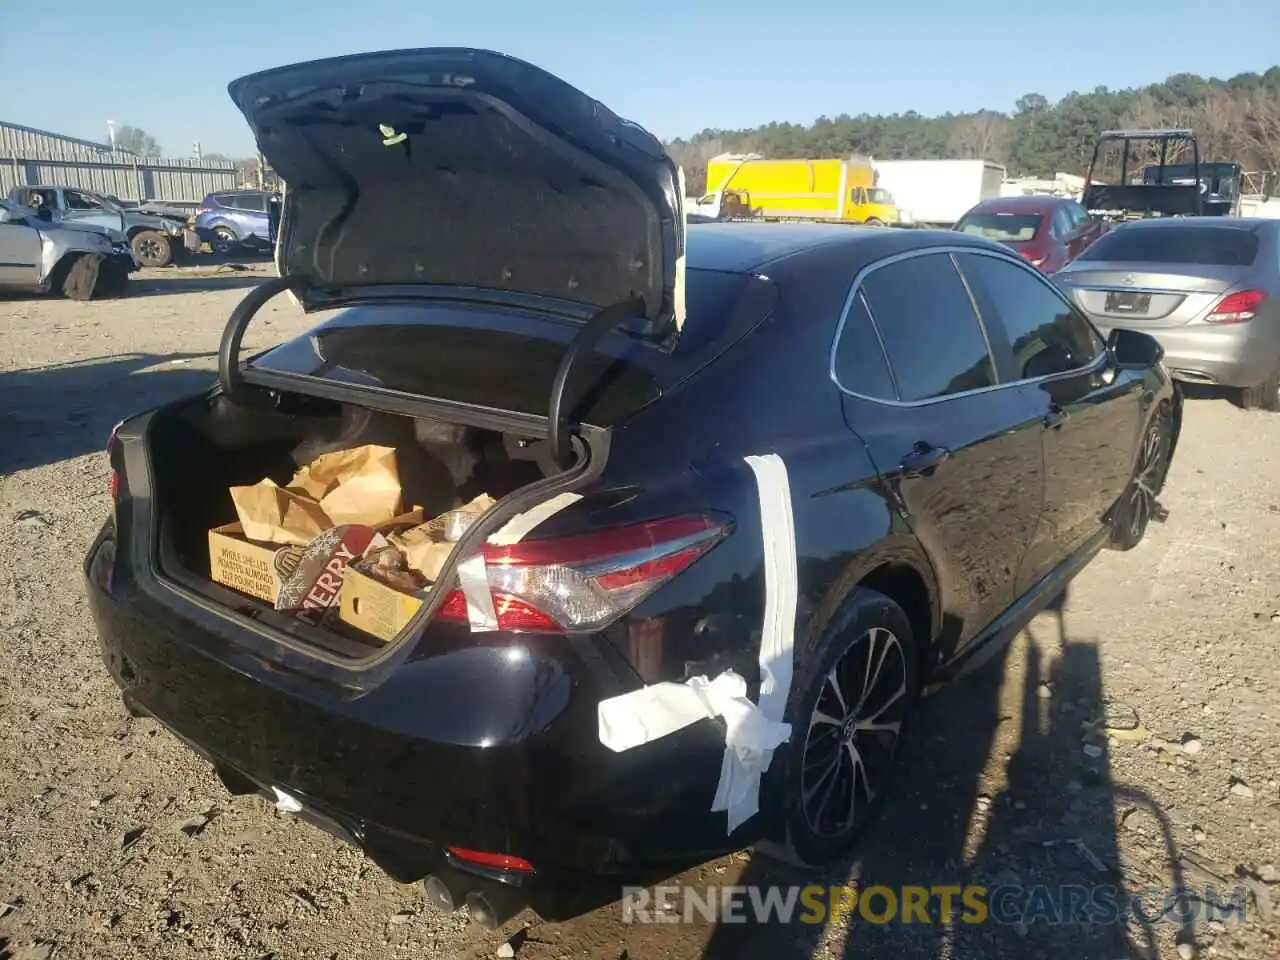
[436,516,727,632]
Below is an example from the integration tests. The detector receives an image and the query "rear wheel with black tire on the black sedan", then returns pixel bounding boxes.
[756,588,919,868]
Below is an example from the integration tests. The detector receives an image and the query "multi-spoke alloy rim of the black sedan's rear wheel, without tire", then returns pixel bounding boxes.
[800,627,909,838]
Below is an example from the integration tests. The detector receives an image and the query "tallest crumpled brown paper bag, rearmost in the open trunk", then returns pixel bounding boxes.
[289,444,401,526]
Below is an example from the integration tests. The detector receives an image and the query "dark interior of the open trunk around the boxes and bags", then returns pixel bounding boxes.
[148,396,561,657]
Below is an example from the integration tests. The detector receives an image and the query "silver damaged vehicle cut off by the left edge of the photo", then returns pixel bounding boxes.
[0,201,138,300]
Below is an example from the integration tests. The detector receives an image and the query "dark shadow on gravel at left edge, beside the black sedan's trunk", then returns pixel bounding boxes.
[0,353,215,474]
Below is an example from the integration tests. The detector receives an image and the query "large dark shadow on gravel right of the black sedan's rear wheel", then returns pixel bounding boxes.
[686,596,1193,960]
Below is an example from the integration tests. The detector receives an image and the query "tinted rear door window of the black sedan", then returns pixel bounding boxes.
[861,252,996,401]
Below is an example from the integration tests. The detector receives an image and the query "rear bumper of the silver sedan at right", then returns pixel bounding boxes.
[1093,317,1280,387]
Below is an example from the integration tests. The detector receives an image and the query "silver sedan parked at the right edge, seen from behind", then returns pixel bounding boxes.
[1053,216,1280,410]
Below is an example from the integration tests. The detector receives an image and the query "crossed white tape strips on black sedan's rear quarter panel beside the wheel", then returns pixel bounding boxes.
[598,453,799,832]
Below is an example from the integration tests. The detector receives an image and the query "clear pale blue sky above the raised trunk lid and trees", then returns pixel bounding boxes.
[0,0,1280,156]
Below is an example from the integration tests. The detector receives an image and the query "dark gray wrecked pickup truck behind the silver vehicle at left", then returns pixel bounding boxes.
[9,187,200,266]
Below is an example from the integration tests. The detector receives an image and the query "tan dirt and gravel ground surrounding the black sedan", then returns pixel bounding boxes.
[0,268,1280,960]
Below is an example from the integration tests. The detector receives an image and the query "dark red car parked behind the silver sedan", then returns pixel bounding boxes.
[955,196,1106,274]
